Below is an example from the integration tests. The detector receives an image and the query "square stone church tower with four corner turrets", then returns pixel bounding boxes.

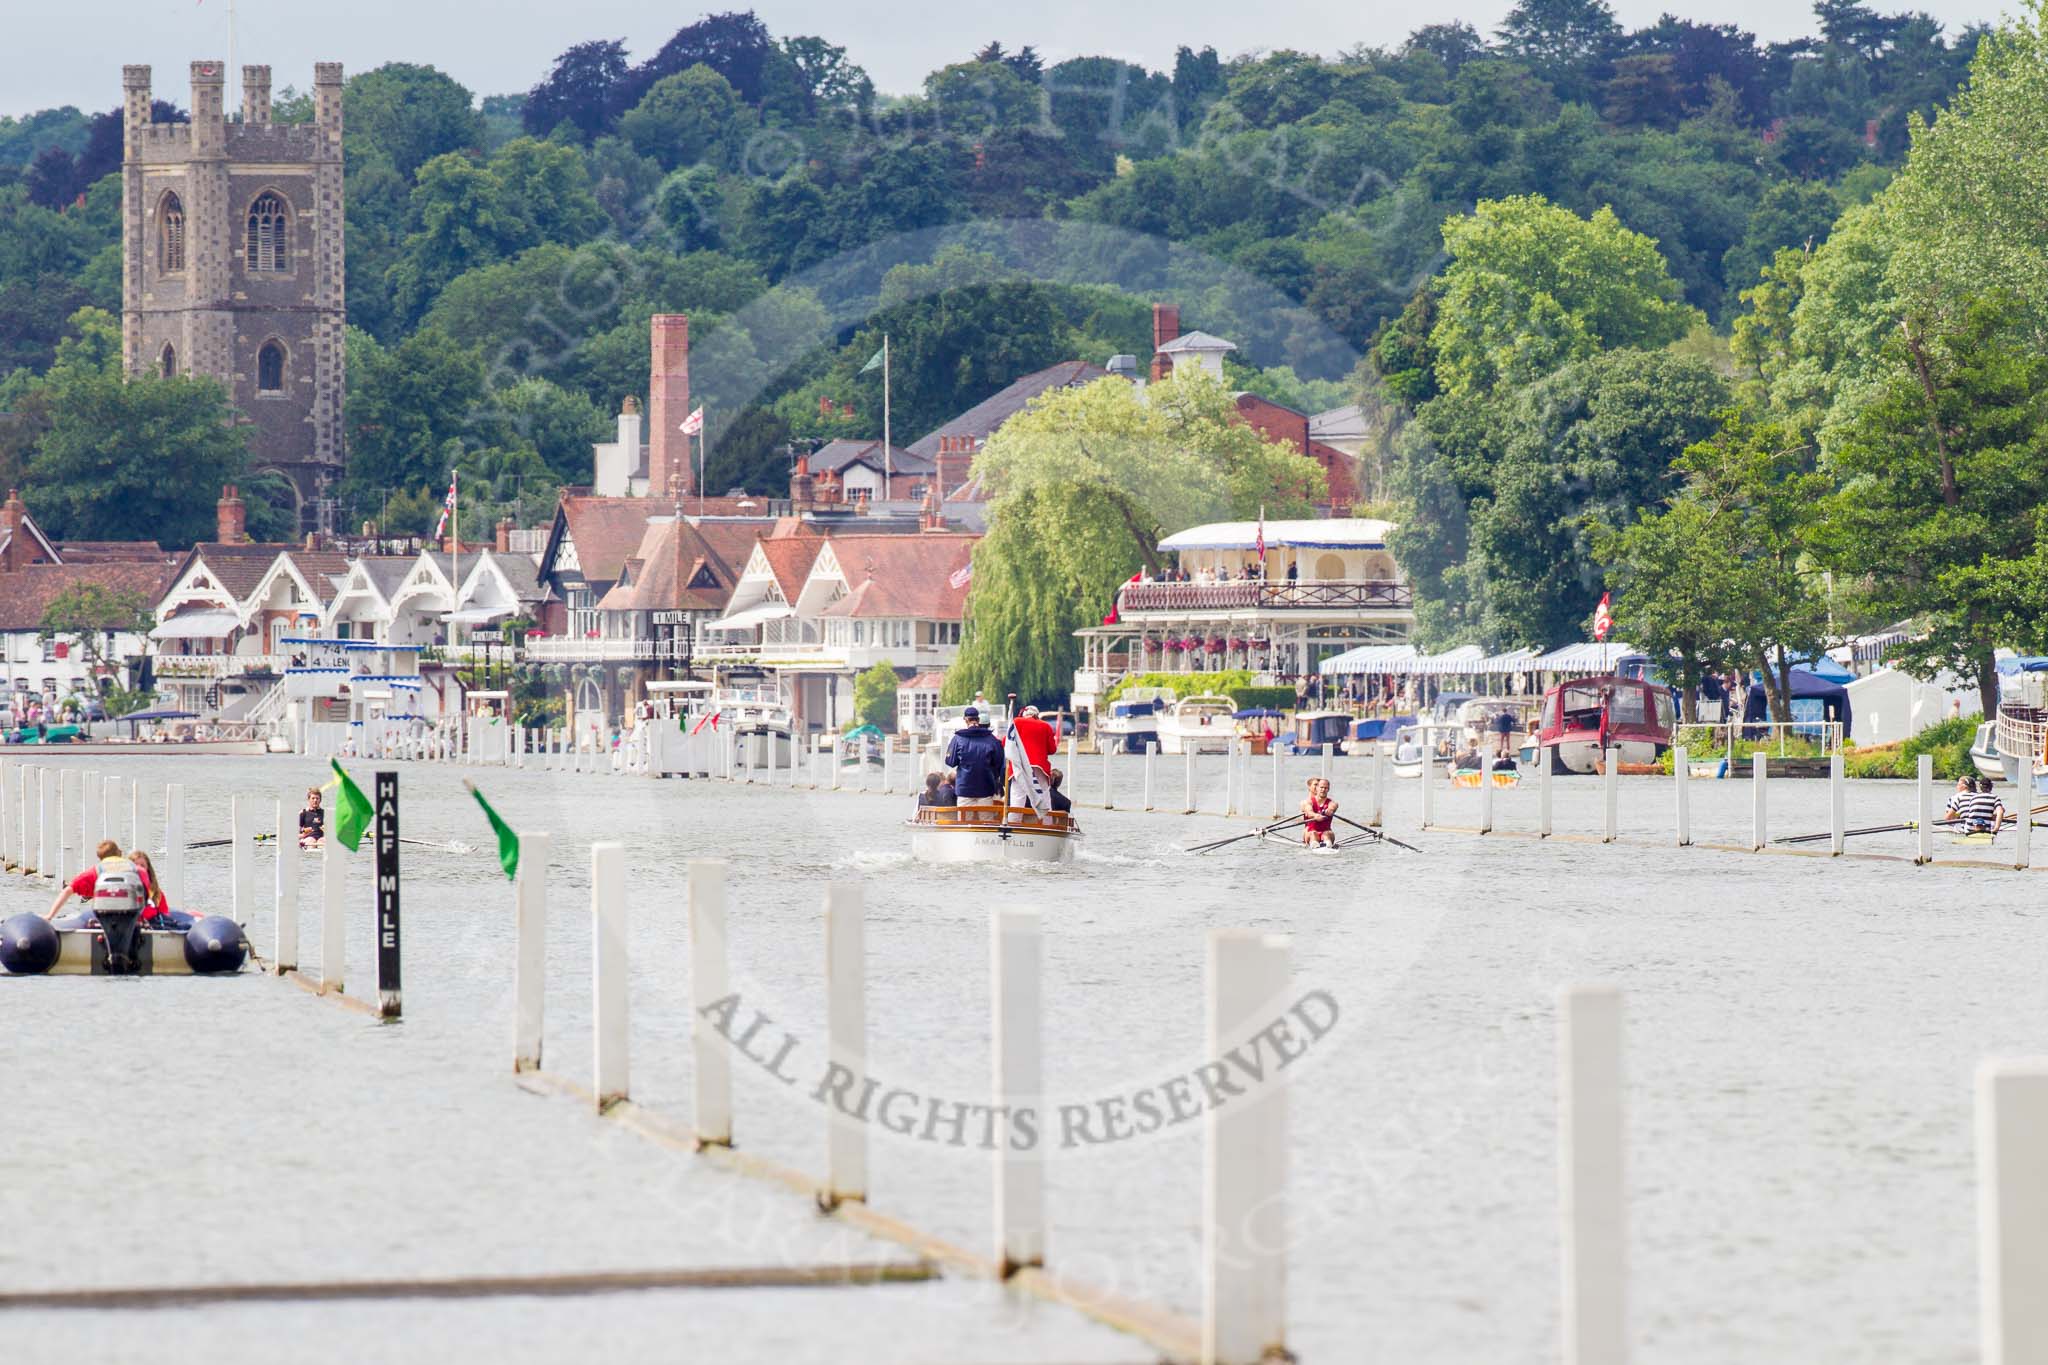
[121,61,346,530]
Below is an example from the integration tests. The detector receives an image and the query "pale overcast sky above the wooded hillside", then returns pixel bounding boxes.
[0,0,2017,115]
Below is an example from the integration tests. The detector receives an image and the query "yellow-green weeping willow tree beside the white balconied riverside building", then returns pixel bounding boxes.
[944,375,1325,702]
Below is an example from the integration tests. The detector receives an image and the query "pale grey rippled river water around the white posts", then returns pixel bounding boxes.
[0,757,2048,1365]
